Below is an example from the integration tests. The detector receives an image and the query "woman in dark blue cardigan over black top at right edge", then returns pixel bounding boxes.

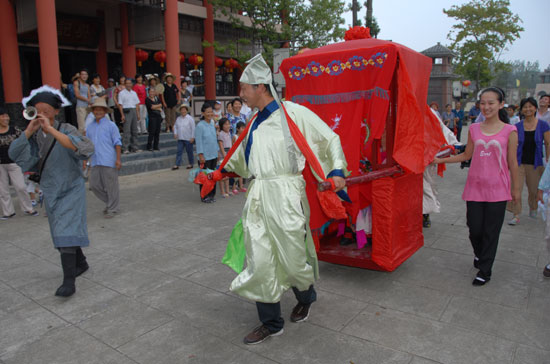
[508,97,550,225]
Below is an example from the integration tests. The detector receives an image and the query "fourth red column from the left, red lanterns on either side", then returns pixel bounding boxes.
[164,0,181,83]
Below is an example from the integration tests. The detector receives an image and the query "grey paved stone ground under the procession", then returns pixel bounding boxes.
[0,161,550,364]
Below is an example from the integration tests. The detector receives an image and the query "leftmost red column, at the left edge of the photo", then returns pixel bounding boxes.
[0,0,23,104]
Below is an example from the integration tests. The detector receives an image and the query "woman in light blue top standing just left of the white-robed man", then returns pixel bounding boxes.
[195,103,219,203]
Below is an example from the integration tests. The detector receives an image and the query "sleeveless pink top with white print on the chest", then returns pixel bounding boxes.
[462,123,516,202]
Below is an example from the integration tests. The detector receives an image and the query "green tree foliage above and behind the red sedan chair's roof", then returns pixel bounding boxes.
[210,0,345,60]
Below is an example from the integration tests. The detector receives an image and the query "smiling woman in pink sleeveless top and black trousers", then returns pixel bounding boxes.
[434,87,520,286]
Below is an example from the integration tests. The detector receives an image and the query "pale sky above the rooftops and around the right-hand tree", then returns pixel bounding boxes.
[345,0,550,71]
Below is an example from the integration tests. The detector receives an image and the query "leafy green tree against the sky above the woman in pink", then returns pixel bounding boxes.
[443,0,524,93]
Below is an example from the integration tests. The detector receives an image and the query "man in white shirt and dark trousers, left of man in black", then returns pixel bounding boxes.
[118,79,139,154]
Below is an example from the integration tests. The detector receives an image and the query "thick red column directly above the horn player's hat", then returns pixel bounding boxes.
[36,0,61,88]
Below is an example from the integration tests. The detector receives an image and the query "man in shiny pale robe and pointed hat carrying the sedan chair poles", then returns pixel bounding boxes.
[225,55,347,344]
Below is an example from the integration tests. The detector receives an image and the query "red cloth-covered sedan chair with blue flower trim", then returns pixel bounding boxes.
[279,39,445,271]
